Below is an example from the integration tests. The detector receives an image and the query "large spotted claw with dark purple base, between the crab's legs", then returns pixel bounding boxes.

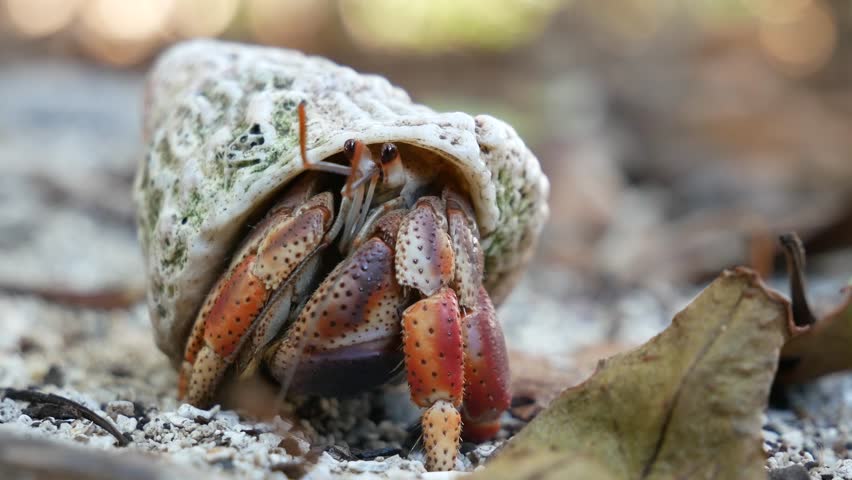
[266,212,406,394]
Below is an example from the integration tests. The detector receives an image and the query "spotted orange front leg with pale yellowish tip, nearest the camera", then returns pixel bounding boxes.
[396,197,464,470]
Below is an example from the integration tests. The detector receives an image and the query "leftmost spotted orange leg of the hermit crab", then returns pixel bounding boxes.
[178,176,334,405]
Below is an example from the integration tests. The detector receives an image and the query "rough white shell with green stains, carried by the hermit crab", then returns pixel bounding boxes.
[135,40,549,361]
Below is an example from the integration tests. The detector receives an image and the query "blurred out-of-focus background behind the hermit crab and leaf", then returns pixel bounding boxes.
[0,0,852,358]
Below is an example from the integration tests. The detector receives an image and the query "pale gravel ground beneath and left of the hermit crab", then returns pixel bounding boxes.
[0,296,502,479]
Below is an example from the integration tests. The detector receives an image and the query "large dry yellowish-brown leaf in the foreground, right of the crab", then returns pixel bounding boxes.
[481,268,791,480]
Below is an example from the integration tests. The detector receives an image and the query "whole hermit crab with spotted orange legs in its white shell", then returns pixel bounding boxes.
[134,40,548,470]
